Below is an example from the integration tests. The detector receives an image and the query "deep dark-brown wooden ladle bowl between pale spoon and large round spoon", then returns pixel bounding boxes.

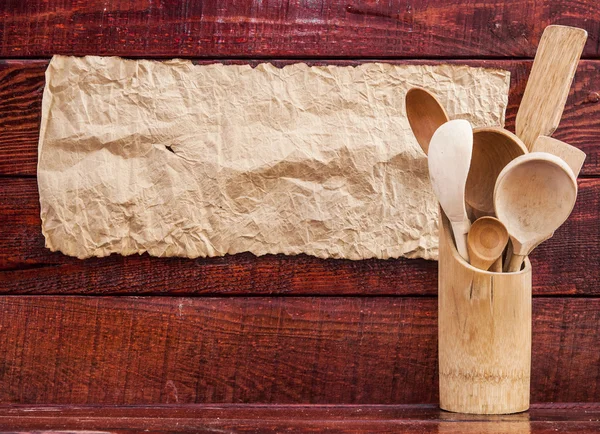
[465,127,527,218]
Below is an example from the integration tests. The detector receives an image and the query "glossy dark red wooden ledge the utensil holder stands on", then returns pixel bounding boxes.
[0,404,600,434]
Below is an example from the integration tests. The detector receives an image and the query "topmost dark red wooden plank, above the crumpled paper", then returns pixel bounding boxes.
[0,0,600,57]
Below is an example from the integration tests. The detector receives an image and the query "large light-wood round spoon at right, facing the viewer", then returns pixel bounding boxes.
[494,152,577,271]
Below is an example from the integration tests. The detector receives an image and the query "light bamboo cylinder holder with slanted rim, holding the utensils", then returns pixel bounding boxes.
[438,211,531,414]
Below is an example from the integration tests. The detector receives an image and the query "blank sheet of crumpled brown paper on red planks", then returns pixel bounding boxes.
[38,56,509,259]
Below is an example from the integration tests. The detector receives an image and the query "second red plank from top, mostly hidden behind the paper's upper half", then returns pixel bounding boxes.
[0,60,600,176]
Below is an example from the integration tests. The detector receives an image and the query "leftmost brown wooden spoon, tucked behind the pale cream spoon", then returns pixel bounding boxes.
[406,87,448,155]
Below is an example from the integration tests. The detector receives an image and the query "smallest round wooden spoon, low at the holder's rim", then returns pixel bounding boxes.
[467,217,508,270]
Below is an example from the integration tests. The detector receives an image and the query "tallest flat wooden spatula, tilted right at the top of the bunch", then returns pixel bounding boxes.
[515,26,587,151]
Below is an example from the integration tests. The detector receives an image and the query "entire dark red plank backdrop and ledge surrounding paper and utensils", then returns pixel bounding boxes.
[0,0,600,433]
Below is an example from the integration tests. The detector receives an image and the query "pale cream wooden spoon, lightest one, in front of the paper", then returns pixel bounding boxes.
[427,119,473,261]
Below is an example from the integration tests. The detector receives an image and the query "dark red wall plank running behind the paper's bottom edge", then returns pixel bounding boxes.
[0,178,600,295]
